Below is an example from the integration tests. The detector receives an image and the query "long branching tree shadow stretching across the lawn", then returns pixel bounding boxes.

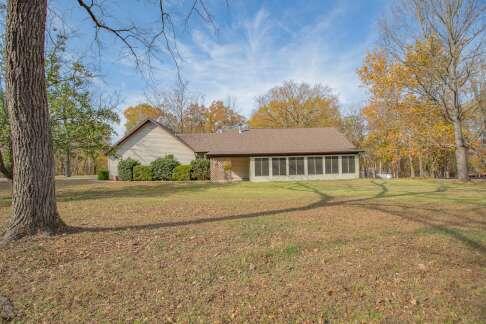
[70,181,486,253]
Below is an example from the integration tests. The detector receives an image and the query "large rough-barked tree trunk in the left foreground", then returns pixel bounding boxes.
[4,0,63,241]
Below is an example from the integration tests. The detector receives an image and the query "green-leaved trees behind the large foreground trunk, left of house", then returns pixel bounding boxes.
[0,34,119,178]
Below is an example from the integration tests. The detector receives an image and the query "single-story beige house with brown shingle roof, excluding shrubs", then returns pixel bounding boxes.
[108,119,361,181]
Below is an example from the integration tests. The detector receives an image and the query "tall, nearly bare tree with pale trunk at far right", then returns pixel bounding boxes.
[382,0,486,180]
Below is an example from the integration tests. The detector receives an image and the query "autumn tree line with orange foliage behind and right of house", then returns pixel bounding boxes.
[124,68,486,178]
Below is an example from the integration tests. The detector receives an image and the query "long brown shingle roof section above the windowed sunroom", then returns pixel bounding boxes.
[176,127,361,155]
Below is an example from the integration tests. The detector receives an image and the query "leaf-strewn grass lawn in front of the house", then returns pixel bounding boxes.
[0,179,486,322]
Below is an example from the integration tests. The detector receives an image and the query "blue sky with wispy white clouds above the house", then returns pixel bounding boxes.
[50,0,387,138]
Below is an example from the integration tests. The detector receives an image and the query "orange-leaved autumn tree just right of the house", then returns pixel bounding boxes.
[358,49,481,177]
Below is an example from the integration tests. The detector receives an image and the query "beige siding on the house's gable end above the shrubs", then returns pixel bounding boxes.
[108,123,195,177]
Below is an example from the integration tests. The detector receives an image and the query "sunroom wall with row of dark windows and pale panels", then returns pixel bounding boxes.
[249,154,359,181]
